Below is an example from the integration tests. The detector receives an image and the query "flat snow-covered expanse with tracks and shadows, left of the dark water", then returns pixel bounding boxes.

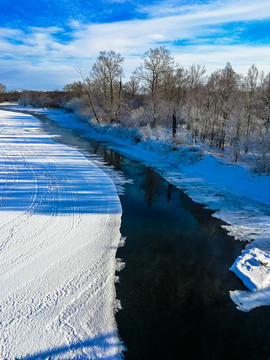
[0,111,121,360]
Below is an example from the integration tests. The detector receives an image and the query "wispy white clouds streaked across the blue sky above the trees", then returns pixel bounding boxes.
[0,0,270,88]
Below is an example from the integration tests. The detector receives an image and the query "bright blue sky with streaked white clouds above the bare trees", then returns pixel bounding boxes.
[0,0,270,90]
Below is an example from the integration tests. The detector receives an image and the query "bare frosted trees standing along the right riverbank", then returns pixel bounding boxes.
[18,47,270,174]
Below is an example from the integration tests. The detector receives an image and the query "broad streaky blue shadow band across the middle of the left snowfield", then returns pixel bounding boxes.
[0,134,121,215]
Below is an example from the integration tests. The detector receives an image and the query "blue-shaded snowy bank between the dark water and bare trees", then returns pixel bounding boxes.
[2,106,270,310]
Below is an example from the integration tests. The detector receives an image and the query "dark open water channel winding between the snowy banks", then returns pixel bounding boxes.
[6,108,270,360]
